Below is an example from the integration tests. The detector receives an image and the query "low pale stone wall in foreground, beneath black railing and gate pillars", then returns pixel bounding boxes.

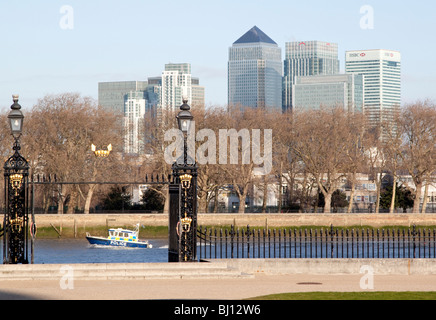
[0,259,436,284]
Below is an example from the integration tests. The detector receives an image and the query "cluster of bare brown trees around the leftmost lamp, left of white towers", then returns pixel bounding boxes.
[0,93,127,213]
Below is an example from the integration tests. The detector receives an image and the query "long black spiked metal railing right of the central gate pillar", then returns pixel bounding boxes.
[197,226,436,259]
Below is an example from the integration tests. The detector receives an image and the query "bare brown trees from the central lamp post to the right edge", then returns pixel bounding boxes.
[148,101,436,212]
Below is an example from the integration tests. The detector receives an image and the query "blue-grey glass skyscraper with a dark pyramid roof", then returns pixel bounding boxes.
[228,26,282,109]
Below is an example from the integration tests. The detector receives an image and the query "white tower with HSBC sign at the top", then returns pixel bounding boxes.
[345,49,401,126]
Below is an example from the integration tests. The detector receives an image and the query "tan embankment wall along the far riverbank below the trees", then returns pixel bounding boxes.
[5,213,436,229]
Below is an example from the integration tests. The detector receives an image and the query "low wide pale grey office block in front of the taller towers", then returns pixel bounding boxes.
[292,74,364,112]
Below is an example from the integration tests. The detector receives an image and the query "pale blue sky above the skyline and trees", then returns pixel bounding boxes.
[0,0,436,109]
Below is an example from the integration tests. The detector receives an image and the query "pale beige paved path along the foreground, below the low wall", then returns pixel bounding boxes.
[0,274,436,300]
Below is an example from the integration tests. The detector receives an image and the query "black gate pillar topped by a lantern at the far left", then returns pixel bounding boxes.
[3,95,29,264]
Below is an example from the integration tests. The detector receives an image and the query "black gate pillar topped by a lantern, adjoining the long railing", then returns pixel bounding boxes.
[168,100,197,262]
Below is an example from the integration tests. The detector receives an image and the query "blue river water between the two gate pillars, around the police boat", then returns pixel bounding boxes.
[29,239,168,264]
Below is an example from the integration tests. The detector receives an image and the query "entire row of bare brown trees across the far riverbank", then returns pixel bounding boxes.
[0,93,436,213]
